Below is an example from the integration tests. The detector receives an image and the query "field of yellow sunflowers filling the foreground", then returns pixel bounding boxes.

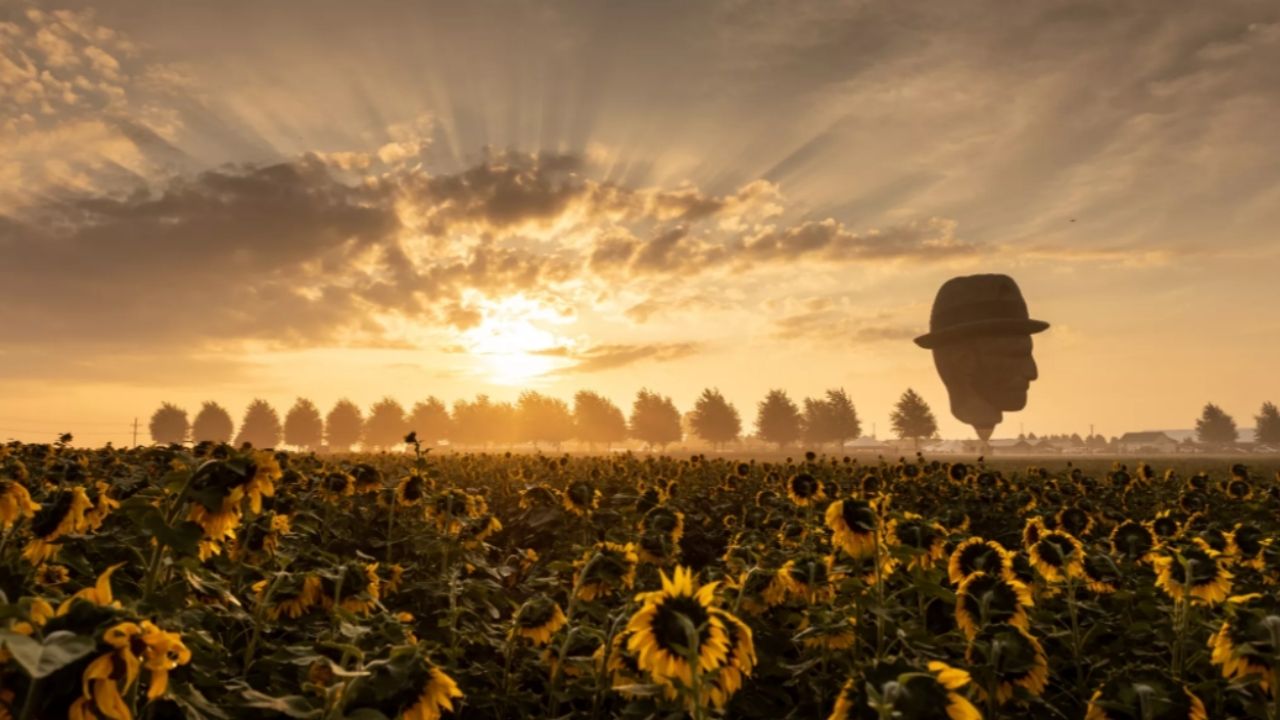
[0,436,1280,720]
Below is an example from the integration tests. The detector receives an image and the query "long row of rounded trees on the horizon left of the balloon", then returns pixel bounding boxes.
[150,388,937,451]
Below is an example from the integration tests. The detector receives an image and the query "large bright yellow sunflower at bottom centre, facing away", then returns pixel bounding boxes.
[627,566,731,688]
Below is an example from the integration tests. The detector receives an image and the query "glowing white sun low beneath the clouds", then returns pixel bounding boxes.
[462,295,573,386]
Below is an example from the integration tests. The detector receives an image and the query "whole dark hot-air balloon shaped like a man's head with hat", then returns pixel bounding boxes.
[915,274,1048,442]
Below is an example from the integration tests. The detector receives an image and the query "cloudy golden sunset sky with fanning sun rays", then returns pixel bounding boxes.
[0,0,1280,443]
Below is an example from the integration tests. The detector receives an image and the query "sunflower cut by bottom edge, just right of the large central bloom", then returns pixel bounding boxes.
[829,660,982,720]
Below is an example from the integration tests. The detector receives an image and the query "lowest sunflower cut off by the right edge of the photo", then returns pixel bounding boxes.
[1208,593,1280,693]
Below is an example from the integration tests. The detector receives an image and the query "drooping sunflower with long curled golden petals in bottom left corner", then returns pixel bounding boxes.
[69,620,191,720]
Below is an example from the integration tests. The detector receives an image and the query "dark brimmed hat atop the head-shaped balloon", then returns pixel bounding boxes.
[915,274,1048,348]
